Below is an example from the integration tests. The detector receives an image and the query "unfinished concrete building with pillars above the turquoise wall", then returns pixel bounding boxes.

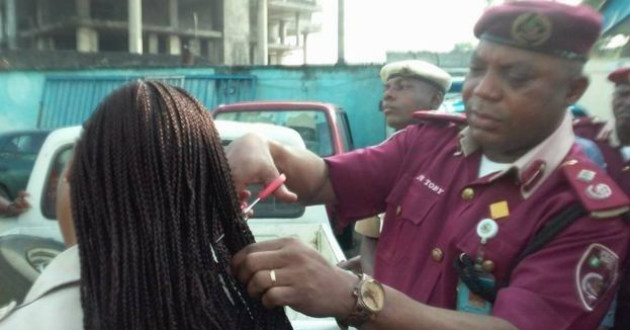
[0,0,321,65]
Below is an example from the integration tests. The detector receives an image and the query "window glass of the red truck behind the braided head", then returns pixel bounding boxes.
[214,110,334,157]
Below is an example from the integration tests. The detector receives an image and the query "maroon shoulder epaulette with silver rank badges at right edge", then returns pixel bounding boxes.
[561,158,630,219]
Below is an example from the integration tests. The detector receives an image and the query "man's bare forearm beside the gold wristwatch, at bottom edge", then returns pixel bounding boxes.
[361,287,517,330]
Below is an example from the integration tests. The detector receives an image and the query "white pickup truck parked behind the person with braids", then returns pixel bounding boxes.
[0,120,344,329]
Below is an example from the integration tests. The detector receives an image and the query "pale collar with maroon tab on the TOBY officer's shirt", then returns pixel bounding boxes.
[459,114,575,198]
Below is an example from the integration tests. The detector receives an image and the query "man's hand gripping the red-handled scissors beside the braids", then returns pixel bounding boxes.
[225,133,297,202]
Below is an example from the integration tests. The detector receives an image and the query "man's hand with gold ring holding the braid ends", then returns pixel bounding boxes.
[232,238,358,317]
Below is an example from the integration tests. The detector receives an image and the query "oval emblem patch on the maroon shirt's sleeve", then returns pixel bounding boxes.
[575,243,619,311]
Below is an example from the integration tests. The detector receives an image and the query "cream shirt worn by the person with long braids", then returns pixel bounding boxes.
[0,245,83,330]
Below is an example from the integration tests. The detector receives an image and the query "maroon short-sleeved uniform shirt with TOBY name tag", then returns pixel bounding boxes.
[326,117,629,330]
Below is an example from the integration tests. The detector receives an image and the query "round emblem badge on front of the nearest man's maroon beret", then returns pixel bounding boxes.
[512,13,552,47]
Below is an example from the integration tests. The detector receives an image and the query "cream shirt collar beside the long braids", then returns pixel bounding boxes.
[22,245,81,306]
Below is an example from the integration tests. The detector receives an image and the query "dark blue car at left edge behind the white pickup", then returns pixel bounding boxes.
[0,131,50,199]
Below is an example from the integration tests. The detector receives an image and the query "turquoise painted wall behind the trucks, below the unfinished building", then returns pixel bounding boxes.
[0,65,385,147]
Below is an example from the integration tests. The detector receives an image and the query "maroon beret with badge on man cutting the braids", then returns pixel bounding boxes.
[475,1,602,61]
